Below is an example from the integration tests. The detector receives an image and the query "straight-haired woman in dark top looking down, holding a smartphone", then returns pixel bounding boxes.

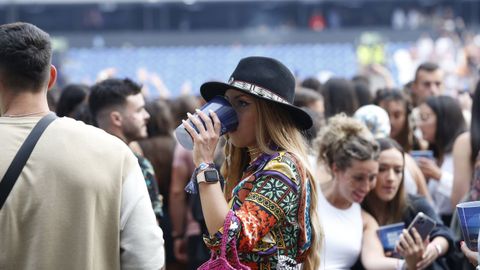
[362,138,453,269]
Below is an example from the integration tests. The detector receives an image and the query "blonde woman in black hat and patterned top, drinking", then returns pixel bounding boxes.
[183,57,321,269]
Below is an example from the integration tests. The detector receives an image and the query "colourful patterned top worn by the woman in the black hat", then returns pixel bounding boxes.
[204,152,311,269]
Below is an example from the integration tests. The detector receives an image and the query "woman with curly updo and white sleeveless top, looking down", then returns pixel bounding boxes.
[317,114,421,270]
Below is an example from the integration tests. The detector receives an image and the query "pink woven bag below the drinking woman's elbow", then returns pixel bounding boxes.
[197,210,250,270]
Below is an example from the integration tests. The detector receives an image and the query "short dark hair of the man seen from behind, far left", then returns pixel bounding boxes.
[0,22,52,91]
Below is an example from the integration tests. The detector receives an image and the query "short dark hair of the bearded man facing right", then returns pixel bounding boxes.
[88,79,142,120]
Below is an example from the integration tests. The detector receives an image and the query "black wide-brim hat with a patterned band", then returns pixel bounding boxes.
[200,56,313,130]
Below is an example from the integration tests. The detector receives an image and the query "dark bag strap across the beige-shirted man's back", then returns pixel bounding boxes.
[0,113,57,210]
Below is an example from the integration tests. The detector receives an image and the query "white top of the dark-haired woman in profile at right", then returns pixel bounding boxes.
[428,153,453,215]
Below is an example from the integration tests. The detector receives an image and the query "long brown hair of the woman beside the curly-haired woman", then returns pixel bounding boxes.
[362,138,408,225]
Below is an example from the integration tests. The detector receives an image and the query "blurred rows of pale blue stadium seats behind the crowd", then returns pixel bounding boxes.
[62,43,409,97]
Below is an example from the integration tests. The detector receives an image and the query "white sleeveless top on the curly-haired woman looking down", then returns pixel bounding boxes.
[318,189,363,270]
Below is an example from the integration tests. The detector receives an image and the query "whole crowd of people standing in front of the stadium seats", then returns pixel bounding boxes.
[0,23,480,270]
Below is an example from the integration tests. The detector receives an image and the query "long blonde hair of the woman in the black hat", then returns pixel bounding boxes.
[221,99,323,270]
